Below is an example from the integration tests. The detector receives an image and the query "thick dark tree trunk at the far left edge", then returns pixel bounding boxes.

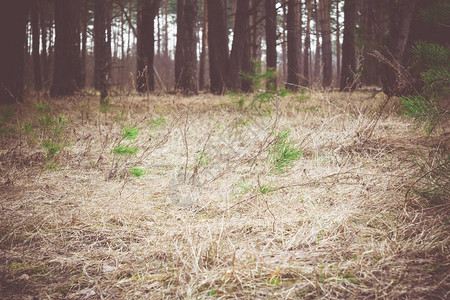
[0,0,29,104]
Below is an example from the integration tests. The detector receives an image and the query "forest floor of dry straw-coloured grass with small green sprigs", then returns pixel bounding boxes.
[0,92,450,299]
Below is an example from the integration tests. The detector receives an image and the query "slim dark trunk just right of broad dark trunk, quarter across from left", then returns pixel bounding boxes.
[94,0,108,103]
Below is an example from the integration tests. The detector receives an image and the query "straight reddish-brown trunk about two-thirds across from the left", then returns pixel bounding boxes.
[286,0,300,91]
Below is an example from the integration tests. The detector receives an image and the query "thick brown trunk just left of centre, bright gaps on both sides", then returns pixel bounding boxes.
[175,0,198,95]
